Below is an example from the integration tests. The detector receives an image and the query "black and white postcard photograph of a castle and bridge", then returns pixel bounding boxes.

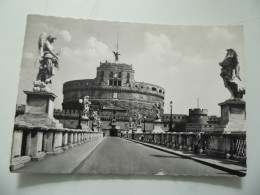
[9,15,247,177]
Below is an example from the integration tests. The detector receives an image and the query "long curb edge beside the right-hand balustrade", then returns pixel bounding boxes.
[125,138,246,177]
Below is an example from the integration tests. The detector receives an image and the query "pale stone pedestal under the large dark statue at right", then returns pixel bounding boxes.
[216,100,246,132]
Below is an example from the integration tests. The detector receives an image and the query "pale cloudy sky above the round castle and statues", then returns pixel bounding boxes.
[17,15,245,116]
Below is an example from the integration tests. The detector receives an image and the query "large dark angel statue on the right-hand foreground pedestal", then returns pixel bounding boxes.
[219,49,245,100]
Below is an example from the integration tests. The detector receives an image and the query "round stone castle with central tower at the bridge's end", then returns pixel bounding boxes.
[63,52,165,120]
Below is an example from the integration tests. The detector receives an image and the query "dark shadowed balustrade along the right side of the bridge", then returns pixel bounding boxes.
[124,132,246,163]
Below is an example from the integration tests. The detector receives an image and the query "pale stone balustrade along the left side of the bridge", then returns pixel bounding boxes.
[10,125,103,170]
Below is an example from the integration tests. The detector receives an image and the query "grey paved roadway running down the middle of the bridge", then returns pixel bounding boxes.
[73,137,230,176]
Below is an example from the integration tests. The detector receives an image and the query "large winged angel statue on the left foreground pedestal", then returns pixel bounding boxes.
[34,32,59,91]
